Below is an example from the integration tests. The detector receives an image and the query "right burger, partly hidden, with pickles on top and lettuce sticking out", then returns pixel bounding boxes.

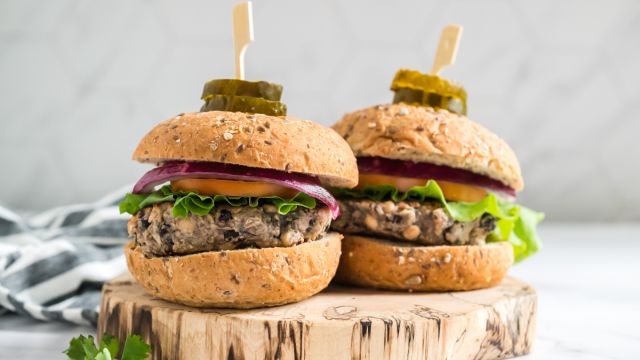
[332,70,542,291]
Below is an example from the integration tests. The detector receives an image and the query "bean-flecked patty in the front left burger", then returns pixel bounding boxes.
[128,203,331,257]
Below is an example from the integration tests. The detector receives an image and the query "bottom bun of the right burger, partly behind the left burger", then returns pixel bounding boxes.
[336,235,513,291]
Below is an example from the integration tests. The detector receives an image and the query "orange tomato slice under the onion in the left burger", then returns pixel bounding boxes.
[171,179,298,199]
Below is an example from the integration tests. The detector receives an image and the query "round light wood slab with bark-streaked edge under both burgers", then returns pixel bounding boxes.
[98,275,537,360]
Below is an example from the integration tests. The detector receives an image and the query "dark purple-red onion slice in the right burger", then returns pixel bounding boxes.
[358,157,516,197]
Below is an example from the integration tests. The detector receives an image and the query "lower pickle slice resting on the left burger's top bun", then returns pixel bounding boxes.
[200,95,287,116]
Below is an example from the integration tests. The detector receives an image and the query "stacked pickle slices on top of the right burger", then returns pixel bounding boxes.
[391,69,467,115]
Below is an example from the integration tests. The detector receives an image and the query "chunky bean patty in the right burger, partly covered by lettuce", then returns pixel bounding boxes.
[331,200,496,245]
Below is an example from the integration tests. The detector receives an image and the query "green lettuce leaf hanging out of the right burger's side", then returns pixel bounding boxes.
[332,180,544,262]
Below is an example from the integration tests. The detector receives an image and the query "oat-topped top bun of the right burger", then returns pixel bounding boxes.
[333,104,524,191]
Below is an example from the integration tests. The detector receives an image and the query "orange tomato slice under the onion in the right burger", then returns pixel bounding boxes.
[357,174,487,202]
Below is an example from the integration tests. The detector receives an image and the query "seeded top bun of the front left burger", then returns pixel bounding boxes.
[133,111,358,188]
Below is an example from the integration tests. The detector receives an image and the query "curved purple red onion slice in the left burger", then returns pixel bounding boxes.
[133,161,340,220]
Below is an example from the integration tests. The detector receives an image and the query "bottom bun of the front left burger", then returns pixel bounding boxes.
[125,233,342,309]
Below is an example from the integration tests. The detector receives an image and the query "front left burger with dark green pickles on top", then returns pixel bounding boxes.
[120,80,358,308]
